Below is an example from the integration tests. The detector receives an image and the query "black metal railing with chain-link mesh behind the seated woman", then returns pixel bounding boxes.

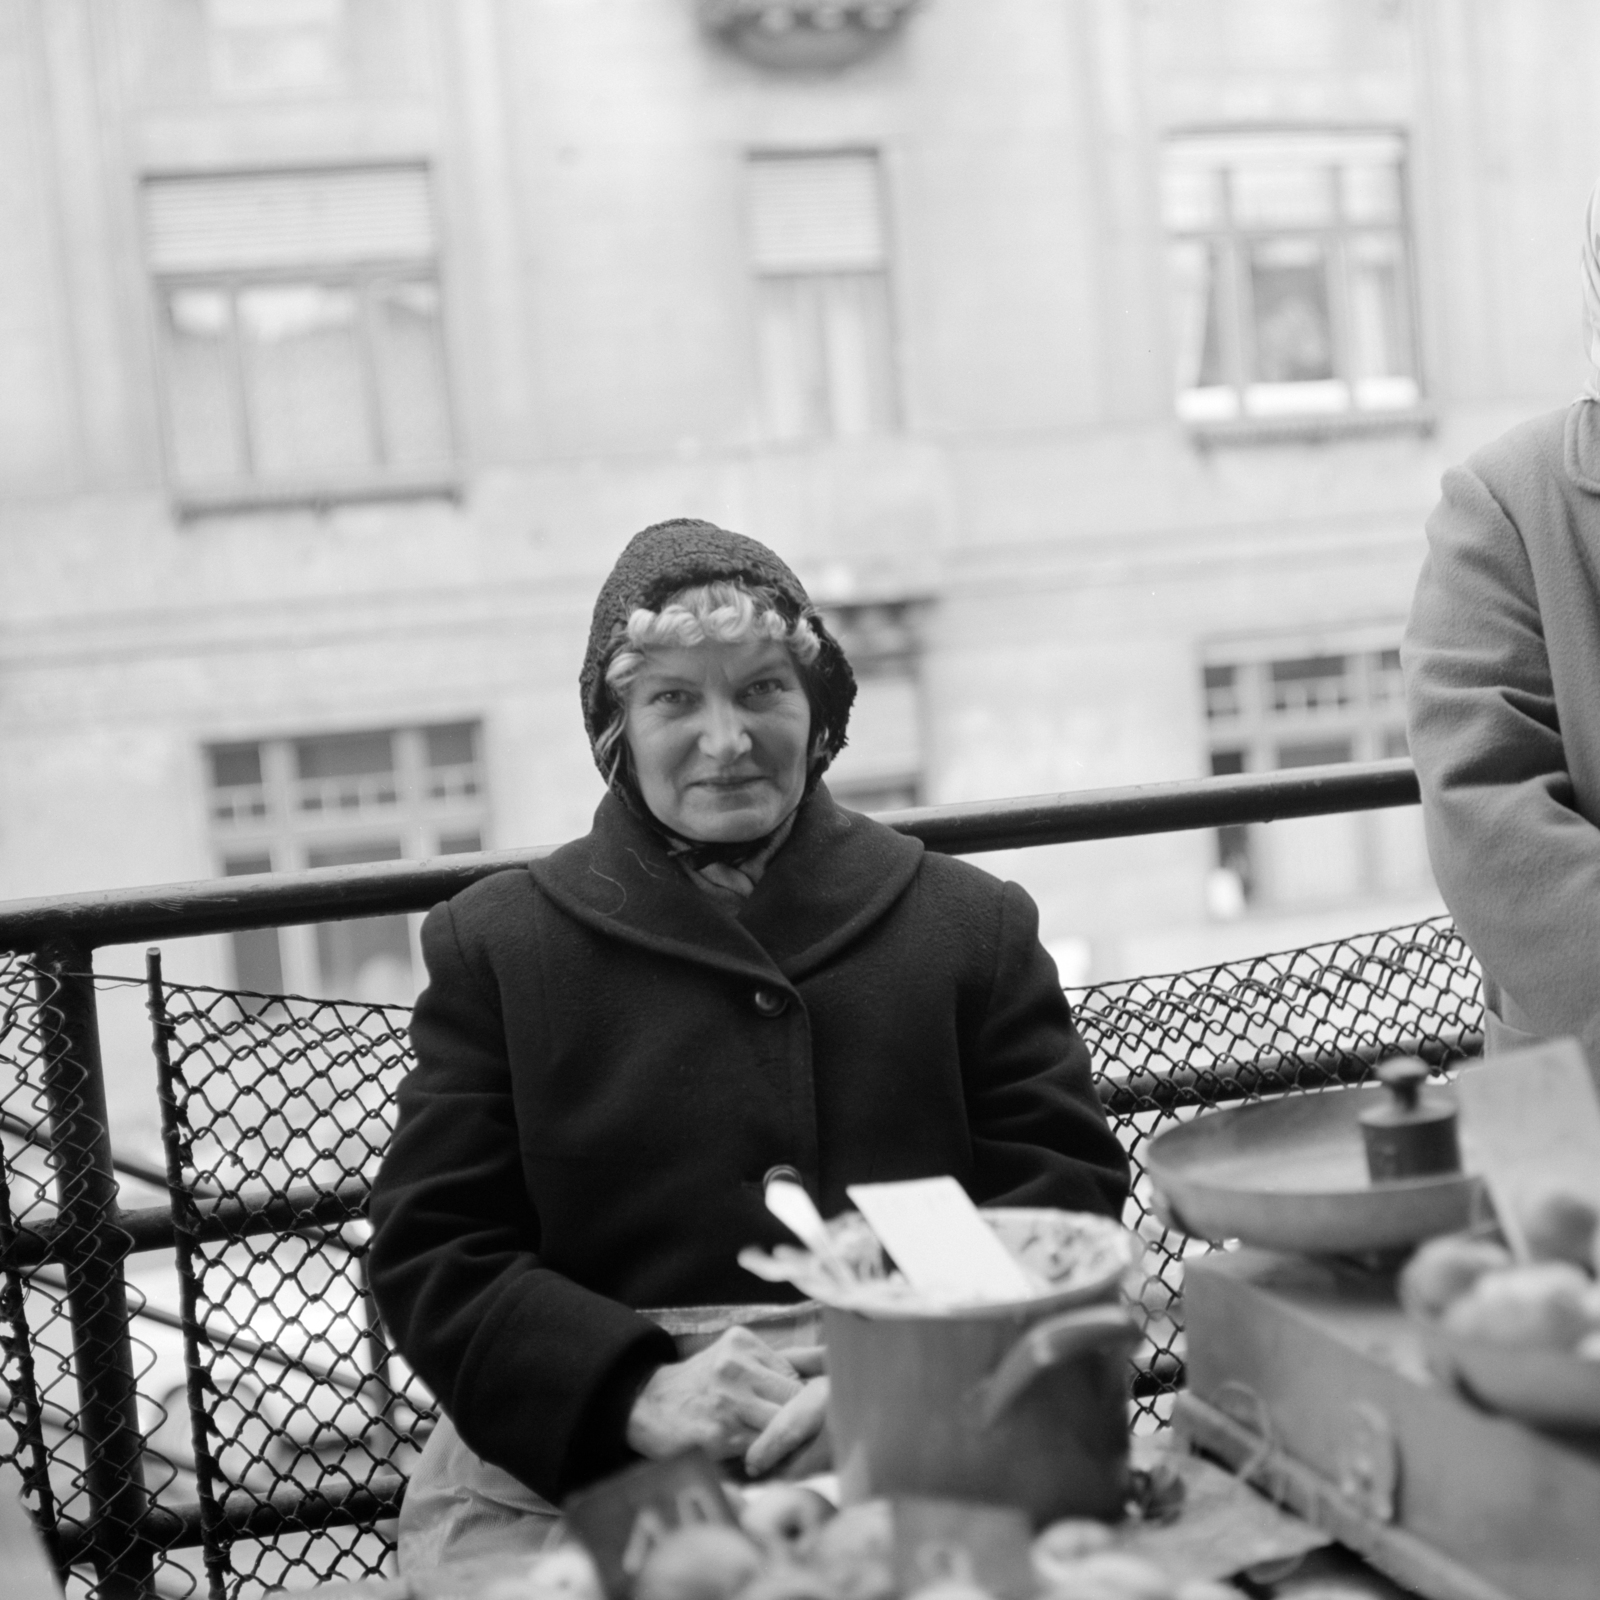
[0,760,1478,1600]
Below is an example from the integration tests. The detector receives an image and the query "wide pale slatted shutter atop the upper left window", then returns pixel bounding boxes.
[144,166,437,272]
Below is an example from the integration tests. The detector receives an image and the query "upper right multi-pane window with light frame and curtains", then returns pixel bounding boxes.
[1162,133,1421,424]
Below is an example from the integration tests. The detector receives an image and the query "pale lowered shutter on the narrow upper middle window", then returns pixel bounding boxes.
[750,154,888,272]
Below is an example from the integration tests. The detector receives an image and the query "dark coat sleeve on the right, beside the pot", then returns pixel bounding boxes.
[965,883,1128,1216]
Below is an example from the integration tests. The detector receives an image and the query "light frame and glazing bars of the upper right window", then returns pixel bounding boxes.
[1158,123,1435,442]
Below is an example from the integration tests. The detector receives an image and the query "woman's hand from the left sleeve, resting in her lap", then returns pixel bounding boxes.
[627,1328,800,1461]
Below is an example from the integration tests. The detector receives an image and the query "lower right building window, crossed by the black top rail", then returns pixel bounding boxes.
[1202,624,1432,917]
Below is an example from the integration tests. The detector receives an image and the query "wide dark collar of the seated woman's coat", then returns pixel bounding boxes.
[528,786,922,982]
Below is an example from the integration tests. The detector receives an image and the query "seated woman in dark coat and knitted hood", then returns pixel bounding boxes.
[371,522,1128,1563]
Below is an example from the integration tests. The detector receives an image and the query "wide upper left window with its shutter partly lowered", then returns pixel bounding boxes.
[144,166,454,506]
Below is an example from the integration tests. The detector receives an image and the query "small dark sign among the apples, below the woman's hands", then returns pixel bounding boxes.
[562,1450,739,1600]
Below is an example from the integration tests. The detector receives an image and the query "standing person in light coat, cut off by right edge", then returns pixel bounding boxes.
[1402,187,1600,1067]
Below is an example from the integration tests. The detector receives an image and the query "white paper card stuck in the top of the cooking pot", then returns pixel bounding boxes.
[845,1178,1038,1304]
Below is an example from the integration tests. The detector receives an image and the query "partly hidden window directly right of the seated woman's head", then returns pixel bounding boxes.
[824,602,923,811]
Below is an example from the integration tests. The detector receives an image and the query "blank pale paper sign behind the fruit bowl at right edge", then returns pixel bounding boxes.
[1456,1038,1600,1256]
